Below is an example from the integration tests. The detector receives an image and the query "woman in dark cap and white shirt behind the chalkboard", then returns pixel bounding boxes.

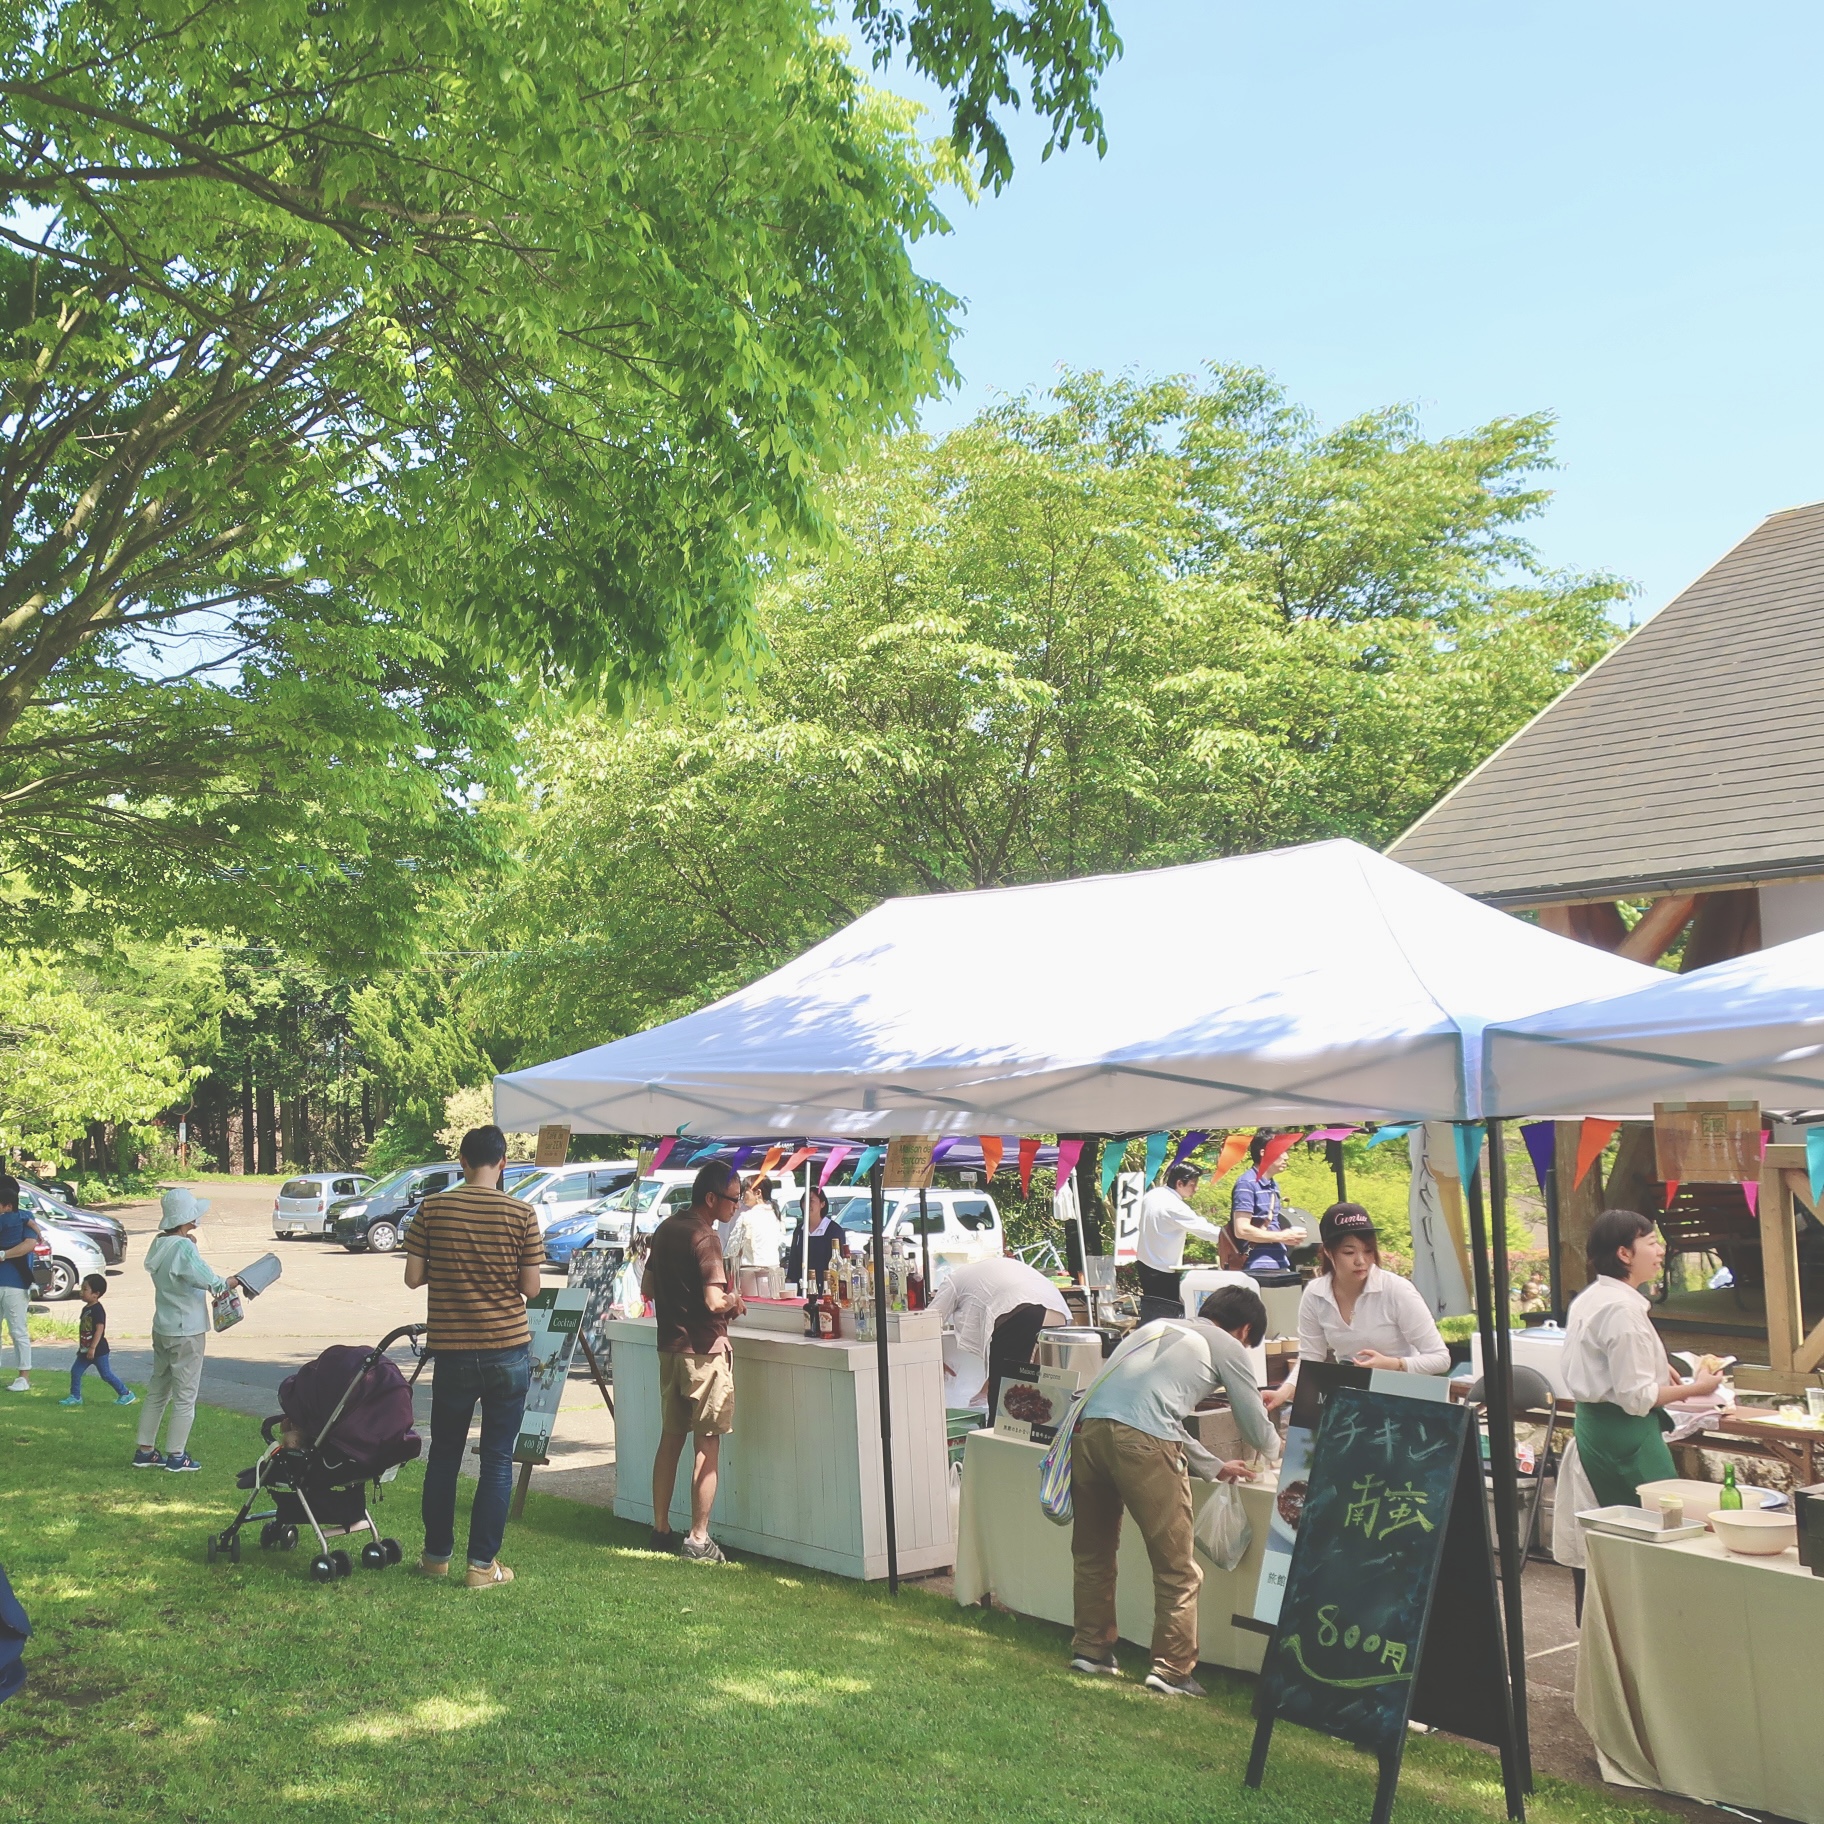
[1266,1204,1450,1410]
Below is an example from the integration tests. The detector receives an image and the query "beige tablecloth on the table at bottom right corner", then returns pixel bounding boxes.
[1576,1532,1824,1824]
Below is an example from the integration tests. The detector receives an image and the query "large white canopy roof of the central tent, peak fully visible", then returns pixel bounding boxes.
[494,841,1653,1136]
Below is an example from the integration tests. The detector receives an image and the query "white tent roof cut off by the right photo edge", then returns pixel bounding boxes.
[1485,934,1824,1114]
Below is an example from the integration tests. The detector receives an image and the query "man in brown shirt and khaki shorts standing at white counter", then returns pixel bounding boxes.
[640,1160,746,1565]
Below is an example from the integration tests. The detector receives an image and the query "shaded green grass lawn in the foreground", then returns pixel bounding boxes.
[0,1377,1662,1824]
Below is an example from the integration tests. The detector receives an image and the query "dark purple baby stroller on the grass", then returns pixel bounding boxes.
[210,1324,425,1583]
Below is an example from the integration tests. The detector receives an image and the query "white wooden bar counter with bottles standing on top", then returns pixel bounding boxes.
[607,1317,956,1578]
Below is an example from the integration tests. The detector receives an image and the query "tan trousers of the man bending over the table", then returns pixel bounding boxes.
[1071,1419,1204,1678]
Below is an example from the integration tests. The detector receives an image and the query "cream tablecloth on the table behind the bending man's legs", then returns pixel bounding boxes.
[956,1432,1275,1673]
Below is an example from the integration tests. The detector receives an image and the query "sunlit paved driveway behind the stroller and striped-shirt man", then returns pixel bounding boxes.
[33,1184,615,1507]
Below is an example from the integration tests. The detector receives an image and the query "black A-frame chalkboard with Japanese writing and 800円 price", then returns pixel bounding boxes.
[1248,1386,1527,1824]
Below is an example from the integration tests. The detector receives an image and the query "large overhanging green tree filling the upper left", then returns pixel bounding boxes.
[0,0,1113,948]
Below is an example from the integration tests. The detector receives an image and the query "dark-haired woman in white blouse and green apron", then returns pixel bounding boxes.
[1560,1209,1722,1507]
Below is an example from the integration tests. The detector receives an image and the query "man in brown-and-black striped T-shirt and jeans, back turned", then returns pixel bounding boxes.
[405,1127,545,1591]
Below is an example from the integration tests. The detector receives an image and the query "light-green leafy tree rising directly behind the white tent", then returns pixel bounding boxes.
[474,368,1623,1060]
